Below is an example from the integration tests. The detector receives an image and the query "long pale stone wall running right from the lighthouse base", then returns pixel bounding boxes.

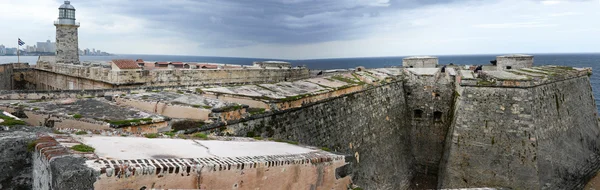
[22,60,309,90]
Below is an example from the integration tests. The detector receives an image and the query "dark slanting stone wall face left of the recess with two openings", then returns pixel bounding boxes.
[218,81,414,189]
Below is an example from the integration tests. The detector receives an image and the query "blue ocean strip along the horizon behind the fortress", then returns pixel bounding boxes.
[0,53,600,110]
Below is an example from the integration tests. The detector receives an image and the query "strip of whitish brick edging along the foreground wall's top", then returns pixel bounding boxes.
[87,152,345,178]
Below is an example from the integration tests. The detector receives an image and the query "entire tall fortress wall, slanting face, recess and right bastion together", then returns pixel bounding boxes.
[198,55,600,189]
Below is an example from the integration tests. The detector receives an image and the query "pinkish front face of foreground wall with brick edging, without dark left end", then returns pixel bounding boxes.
[87,153,350,190]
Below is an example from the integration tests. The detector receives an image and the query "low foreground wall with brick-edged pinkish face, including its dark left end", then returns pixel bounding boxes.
[33,135,351,190]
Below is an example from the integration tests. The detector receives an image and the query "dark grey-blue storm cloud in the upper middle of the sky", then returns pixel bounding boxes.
[68,0,460,47]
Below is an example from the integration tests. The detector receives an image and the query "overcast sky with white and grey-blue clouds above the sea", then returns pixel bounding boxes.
[0,0,600,59]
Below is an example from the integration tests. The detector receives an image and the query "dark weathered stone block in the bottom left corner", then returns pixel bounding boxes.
[0,126,48,190]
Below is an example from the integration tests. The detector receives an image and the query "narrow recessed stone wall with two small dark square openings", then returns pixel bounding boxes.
[402,68,454,189]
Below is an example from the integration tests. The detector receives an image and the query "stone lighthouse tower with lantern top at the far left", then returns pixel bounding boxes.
[54,1,79,64]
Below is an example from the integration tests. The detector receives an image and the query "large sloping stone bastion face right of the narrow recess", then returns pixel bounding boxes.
[439,76,600,189]
